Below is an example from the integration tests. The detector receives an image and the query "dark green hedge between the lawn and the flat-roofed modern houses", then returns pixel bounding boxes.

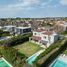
[4,33,32,46]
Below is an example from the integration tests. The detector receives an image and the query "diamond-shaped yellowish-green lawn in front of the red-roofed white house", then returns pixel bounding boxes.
[14,42,42,57]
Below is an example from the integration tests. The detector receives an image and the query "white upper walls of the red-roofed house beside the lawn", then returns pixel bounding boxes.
[33,31,59,44]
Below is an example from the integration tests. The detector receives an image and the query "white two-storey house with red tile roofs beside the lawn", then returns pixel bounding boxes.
[32,29,59,47]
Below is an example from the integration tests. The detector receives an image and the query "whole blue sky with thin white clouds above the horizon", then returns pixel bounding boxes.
[0,0,67,18]
